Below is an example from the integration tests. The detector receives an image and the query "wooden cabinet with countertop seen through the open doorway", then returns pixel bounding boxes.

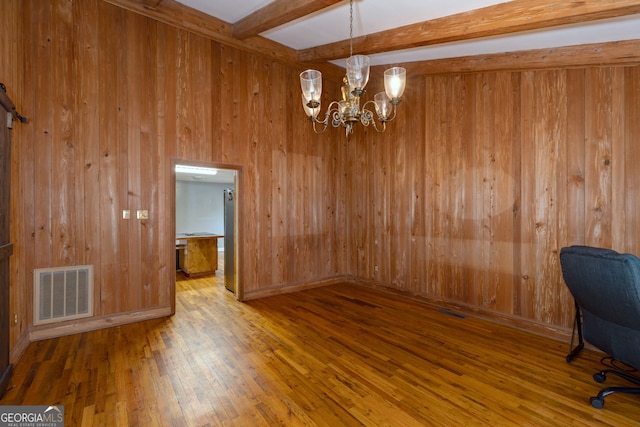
[176,233,224,277]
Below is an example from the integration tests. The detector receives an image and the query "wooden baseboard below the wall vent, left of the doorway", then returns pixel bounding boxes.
[29,307,172,342]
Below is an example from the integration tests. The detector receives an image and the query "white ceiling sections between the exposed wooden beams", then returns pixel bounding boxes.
[178,0,640,66]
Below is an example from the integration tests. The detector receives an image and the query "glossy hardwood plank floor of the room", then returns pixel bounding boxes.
[0,274,640,427]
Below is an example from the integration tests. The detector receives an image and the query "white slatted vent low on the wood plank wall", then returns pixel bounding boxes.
[33,265,93,325]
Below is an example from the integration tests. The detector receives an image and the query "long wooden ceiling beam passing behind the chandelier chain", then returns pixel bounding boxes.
[298,0,640,61]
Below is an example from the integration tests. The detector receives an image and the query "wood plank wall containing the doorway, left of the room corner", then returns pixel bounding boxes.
[2,0,346,354]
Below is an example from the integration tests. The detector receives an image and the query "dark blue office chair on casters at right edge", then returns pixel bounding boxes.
[560,246,640,408]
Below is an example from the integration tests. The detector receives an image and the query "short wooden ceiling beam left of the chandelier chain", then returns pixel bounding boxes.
[232,0,342,40]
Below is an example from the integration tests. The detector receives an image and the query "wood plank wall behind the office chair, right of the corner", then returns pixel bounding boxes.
[348,66,640,328]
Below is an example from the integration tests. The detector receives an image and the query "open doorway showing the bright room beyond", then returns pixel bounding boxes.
[171,159,242,304]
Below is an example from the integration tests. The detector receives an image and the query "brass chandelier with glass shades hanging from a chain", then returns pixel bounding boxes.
[300,0,407,136]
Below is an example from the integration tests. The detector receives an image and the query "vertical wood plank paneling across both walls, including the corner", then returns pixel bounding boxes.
[0,0,640,358]
